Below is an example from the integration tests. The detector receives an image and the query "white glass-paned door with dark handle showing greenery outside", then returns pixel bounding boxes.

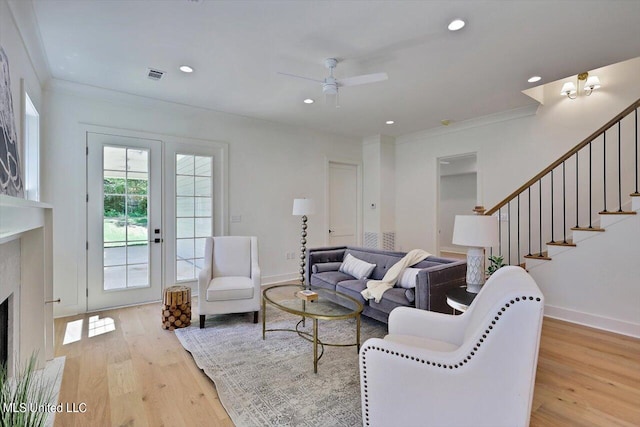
[87,132,163,310]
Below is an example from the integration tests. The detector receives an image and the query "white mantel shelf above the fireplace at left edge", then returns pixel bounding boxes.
[0,195,53,243]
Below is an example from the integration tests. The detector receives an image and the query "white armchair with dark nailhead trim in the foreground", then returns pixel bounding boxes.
[359,266,544,427]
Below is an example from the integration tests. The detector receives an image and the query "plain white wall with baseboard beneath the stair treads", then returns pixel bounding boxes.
[529,207,640,337]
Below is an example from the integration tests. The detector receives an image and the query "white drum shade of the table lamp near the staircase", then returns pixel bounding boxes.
[452,215,498,248]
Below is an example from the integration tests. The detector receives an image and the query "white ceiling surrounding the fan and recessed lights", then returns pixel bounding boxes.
[33,0,640,137]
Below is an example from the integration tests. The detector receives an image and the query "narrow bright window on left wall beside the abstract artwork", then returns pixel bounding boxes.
[24,92,40,201]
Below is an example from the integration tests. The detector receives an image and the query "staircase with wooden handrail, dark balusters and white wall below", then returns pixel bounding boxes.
[485,100,640,337]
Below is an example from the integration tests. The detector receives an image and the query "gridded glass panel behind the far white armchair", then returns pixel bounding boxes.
[176,154,213,282]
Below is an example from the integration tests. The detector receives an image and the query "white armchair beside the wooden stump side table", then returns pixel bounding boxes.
[198,236,261,328]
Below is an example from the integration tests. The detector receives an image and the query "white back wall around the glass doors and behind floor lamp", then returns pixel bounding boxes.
[43,81,362,315]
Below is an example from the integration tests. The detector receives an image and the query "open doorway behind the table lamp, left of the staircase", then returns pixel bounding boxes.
[438,153,478,258]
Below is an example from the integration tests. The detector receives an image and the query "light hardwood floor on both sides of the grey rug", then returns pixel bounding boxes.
[55,304,640,427]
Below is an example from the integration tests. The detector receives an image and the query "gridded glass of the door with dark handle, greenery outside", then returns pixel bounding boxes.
[102,146,150,290]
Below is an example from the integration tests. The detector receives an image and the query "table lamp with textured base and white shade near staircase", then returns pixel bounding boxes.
[452,215,498,294]
